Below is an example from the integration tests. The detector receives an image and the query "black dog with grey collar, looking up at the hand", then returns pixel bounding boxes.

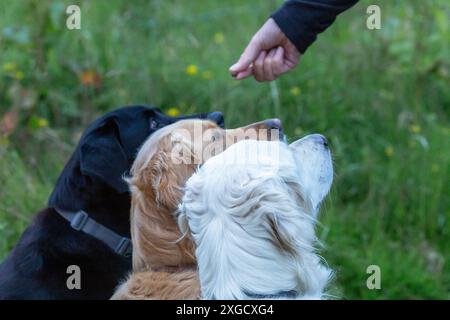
[0,106,224,299]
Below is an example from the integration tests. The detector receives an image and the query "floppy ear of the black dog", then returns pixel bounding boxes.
[80,123,129,193]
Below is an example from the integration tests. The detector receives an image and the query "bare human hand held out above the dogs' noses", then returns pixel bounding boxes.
[229,18,300,82]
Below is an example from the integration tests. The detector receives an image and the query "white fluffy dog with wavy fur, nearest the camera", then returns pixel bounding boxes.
[178,134,333,299]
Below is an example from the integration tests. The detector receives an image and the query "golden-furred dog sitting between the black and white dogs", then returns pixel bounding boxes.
[112,120,276,299]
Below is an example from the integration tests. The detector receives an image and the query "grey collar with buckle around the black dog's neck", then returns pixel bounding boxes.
[54,208,133,257]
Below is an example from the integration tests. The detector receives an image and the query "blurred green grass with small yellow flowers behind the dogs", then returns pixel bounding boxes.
[0,0,450,299]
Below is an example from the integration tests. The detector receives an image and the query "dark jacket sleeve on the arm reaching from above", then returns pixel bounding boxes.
[272,0,358,54]
